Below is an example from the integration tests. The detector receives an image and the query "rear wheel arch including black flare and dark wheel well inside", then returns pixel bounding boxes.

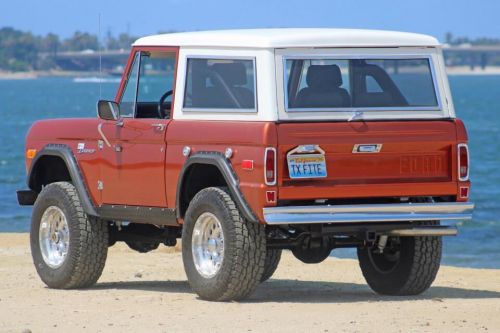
[176,152,258,223]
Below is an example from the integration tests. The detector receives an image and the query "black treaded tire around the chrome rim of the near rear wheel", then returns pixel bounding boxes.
[182,187,266,301]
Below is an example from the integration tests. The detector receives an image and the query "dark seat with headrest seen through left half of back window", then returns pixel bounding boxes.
[293,65,351,108]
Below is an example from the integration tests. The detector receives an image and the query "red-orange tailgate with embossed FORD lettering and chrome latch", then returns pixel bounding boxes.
[278,121,456,199]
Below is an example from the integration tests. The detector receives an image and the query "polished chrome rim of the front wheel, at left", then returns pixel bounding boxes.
[38,206,69,268]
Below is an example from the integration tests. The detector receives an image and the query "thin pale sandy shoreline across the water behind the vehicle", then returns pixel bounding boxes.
[0,66,500,80]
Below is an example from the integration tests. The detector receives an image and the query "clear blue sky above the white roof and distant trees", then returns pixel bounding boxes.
[0,0,500,40]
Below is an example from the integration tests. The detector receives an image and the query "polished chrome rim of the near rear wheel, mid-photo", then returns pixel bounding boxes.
[191,212,224,278]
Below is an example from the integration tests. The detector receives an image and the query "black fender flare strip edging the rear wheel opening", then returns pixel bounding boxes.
[176,152,259,223]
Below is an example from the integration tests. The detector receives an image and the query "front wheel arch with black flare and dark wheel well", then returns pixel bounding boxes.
[27,144,99,216]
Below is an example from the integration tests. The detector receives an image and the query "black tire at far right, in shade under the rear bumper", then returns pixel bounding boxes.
[358,223,442,296]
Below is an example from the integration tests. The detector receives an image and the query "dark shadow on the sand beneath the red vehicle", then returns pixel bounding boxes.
[90,279,500,303]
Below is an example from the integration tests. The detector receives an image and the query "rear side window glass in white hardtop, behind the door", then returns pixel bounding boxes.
[184,58,256,112]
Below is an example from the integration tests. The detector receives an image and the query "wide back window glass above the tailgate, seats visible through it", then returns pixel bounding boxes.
[285,58,439,111]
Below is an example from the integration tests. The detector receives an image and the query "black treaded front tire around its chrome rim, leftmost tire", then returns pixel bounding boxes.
[30,182,108,289]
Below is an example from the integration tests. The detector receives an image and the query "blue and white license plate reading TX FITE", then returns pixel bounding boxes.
[287,154,326,179]
